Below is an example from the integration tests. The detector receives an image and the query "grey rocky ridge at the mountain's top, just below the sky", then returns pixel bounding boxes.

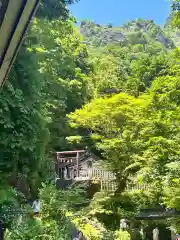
[80,19,180,49]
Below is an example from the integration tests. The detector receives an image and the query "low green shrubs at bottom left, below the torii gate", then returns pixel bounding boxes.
[6,186,85,240]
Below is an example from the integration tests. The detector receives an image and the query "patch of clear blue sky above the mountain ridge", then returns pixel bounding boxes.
[69,0,170,26]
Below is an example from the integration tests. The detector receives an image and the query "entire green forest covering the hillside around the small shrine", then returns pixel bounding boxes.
[0,0,180,240]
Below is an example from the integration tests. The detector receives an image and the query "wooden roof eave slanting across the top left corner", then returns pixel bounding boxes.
[0,0,40,87]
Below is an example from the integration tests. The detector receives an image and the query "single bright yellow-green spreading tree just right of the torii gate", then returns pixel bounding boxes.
[69,93,148,192]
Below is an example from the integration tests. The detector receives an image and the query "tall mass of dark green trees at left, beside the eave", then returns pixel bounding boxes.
[0,1,89,202]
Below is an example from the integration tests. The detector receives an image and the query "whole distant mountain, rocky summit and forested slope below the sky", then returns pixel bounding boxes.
[76,19,180,96]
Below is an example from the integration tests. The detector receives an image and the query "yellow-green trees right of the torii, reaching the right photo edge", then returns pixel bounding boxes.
[69,47,179,204]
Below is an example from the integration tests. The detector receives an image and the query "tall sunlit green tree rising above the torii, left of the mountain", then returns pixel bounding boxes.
[32,19,91,151]
